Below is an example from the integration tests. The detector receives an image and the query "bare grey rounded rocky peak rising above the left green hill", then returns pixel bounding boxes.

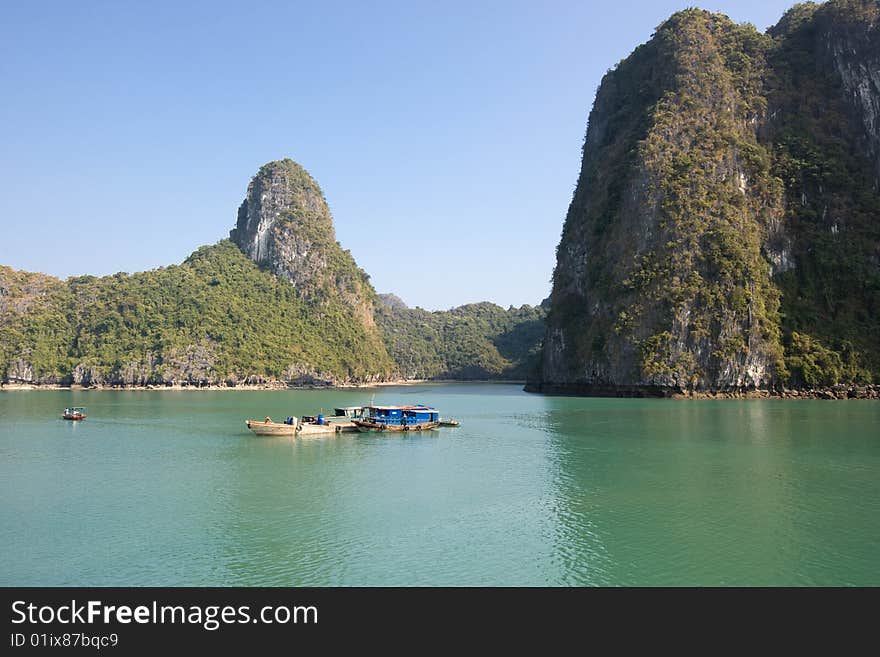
[229,159,375,326]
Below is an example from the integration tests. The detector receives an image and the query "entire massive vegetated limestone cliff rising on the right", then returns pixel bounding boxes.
[529,1,880,394]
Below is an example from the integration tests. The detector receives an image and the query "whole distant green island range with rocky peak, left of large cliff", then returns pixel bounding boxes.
[0,159,545,388]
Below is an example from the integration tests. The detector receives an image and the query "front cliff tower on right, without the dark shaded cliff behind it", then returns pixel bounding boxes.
[542,10,781,389]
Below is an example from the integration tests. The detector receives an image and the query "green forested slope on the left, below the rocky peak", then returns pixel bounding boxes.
[0,241,394,385]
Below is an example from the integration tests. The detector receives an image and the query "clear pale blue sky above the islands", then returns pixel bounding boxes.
[0,0,793,309]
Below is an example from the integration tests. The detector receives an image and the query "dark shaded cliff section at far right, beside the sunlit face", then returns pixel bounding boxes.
[767,0,880,385]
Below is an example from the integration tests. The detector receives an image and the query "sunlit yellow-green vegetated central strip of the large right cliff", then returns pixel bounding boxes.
[623,10,784,387]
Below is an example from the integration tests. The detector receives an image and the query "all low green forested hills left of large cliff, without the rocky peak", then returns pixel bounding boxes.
[0,247,544,385]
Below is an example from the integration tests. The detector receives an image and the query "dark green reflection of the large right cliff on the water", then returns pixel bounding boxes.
[546,398,880,585]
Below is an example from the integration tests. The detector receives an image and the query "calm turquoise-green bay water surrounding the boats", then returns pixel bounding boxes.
[0,384,880,586]
